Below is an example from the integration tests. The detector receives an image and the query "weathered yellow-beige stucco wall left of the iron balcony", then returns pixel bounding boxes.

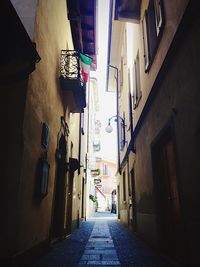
[16,0,78,255]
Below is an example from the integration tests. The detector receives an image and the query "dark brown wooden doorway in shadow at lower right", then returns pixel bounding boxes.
[152,128,185,263]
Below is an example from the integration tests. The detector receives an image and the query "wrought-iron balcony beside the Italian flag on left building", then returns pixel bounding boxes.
[60,50,86,113]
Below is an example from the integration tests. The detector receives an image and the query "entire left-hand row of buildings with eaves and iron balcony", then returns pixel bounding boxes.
[0,0,96,266]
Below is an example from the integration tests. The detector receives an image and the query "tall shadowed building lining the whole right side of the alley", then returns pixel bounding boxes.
[109,0,200,266]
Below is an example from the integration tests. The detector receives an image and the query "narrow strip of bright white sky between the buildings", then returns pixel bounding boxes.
[91,0,117,161]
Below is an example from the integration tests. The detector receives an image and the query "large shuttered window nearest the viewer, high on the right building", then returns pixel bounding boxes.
[142,0,164,71]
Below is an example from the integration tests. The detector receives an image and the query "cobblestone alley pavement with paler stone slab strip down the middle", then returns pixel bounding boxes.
[33,212,171,267]
